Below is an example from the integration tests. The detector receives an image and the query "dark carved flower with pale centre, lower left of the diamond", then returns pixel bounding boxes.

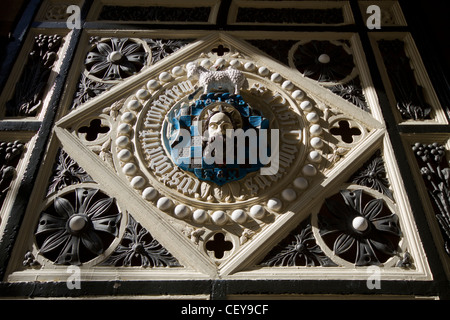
[35,188,122,265]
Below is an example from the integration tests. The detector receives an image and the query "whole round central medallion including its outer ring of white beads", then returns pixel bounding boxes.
[115,50,336,225]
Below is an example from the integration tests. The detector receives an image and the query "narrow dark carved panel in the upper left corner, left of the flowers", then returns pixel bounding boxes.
[6,34,62,117]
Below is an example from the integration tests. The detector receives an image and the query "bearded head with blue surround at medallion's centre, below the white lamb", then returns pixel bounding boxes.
[163,92,270,186]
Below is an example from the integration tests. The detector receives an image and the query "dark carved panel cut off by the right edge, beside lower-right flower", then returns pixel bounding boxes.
[412,143,450,256]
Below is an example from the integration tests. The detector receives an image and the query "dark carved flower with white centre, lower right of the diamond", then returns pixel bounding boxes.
[319,190,401,266]
